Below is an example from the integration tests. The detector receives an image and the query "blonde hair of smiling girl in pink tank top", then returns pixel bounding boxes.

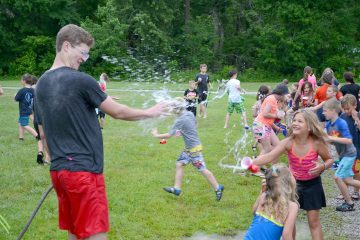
[289,108,327,144]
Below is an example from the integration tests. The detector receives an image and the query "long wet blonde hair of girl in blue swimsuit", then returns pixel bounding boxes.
[261,163,298,223]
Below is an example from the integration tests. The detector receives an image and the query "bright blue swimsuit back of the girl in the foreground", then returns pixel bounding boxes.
[244,212,284,240]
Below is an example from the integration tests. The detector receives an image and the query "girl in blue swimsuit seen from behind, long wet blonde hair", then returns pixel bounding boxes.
[244,164,299,240]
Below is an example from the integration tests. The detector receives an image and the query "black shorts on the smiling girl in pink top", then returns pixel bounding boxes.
[296,176,326,211]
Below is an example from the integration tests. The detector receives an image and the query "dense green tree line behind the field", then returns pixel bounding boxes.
[0,0,360,80]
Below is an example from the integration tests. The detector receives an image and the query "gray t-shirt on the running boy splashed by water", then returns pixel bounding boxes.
[169,111,200,149]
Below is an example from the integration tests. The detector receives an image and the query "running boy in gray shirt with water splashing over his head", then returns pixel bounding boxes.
[152,98,224,201]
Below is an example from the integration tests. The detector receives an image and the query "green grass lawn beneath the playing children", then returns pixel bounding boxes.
[0,81,344,240]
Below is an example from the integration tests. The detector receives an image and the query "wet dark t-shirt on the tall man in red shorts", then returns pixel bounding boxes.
[35,67,107,173]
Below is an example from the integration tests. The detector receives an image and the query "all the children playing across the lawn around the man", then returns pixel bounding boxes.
[15,64,360,239]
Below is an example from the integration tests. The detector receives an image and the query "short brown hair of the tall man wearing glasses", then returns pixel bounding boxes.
[56,24,95,52]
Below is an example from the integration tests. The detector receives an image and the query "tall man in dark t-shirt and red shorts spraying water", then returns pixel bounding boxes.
[35,24,164,239]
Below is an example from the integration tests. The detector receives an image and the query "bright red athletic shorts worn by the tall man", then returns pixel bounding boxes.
[50,170,109,239]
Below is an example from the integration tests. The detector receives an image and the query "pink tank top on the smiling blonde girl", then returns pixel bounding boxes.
[288,143,319,181]
